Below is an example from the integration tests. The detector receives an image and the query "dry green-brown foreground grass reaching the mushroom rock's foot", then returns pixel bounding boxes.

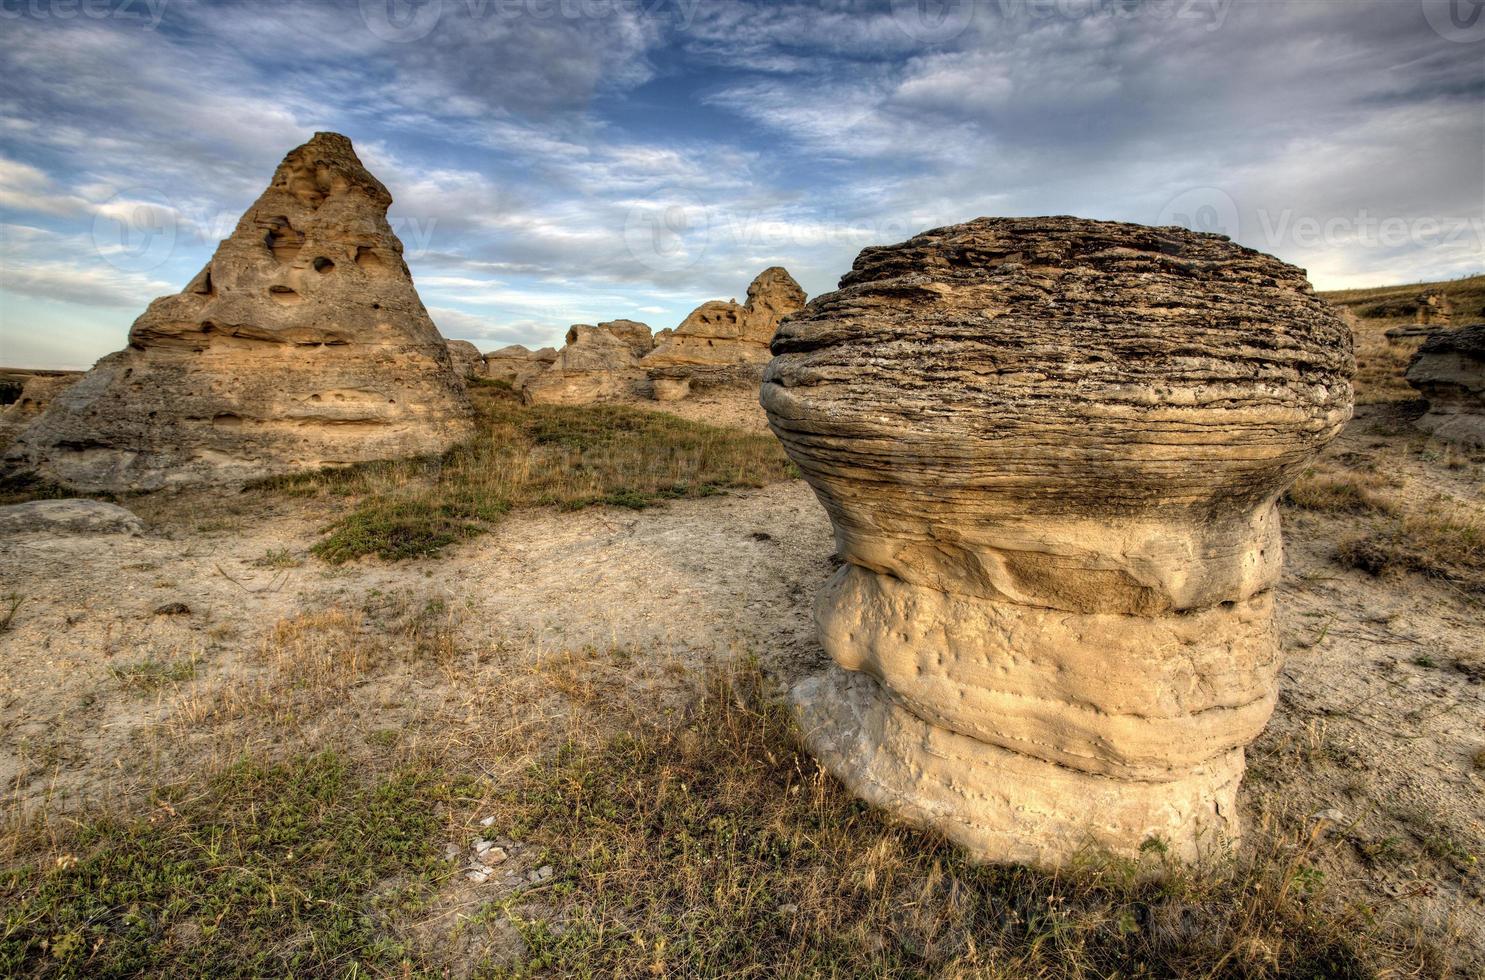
[0,647,1440,977]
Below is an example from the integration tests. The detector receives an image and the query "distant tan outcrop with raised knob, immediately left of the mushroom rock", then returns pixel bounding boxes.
[643,266,805,396]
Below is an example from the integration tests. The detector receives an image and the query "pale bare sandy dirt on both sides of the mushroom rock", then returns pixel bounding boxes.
[0,386,1485,958]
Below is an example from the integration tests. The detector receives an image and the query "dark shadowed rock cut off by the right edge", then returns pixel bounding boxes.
[1408,324,1485,447]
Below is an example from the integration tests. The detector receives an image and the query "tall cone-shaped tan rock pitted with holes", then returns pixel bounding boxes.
[9,132,472,491]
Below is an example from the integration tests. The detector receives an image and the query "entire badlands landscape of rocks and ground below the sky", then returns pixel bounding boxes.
[0,134,1485,977]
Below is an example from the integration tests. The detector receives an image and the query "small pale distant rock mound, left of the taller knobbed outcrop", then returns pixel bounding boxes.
[521,319,653,405]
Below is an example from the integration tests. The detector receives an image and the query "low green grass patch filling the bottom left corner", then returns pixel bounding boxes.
[0,753,472,977]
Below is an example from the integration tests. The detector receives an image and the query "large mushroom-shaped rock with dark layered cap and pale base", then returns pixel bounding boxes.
[762,217,1353,866]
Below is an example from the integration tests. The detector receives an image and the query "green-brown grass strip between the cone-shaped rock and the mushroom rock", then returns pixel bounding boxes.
[257,385,793,563]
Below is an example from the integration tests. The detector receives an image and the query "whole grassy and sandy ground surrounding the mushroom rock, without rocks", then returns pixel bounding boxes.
[0,271,1485,976]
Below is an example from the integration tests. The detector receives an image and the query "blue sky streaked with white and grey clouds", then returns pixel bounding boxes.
[0,0,1485,368]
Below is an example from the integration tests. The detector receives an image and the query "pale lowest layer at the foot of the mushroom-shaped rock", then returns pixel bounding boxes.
[792,667,1243,867]
